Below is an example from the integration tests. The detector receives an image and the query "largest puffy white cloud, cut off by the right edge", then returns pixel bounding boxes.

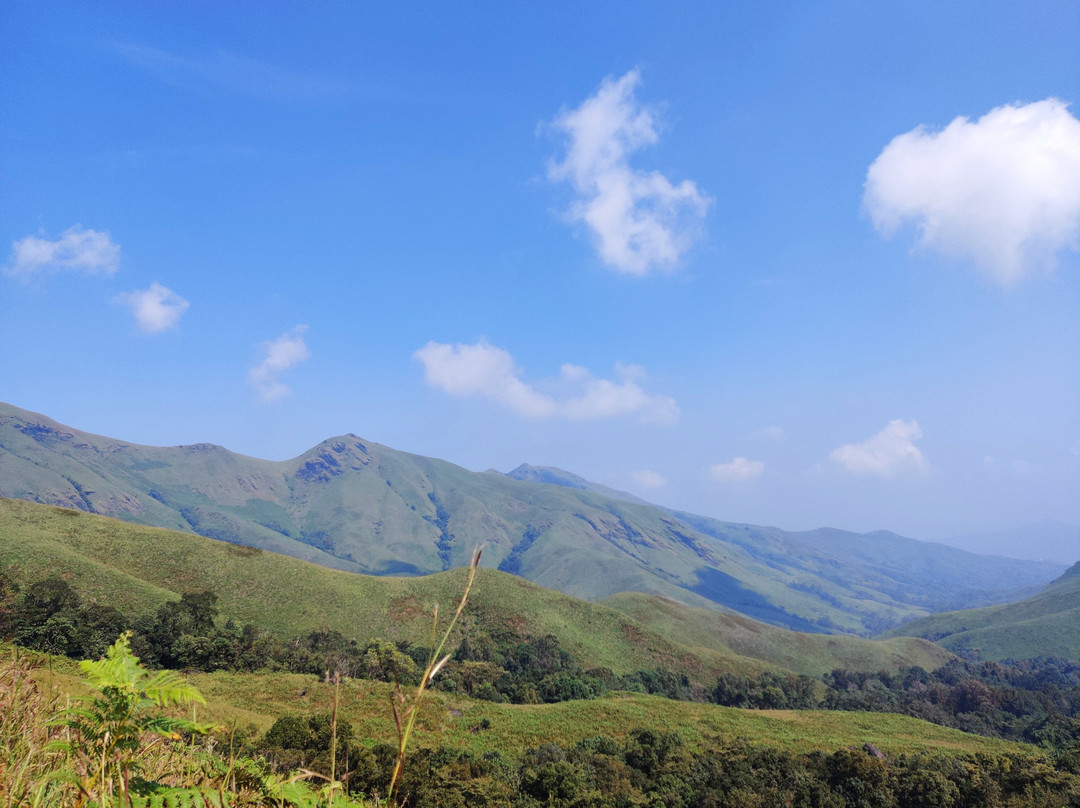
[863,98,1080,285]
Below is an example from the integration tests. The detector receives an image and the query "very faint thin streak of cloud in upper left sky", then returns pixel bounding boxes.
[110,42,350,100]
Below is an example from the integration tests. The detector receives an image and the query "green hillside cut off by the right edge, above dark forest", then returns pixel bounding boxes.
[887,562,1080,659]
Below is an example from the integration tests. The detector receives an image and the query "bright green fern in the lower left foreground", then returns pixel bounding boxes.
[53,632,212,808]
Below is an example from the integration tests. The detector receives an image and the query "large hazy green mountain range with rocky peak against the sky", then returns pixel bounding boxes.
[0,405,1064,634]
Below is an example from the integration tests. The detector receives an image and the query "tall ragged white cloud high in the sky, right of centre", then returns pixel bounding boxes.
[548,70,710,275]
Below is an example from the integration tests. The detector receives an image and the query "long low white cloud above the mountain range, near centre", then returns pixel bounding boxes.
[413,340,679,423]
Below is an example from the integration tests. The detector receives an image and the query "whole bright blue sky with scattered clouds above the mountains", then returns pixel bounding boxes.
[0,1,1080,546]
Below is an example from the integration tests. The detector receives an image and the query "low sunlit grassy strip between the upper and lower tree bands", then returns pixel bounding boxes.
[10,643,1028,759]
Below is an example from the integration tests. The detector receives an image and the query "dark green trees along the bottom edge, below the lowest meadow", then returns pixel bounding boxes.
[250,714,1080,808]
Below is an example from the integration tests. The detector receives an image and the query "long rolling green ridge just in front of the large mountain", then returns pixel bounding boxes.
[0,500,944,683]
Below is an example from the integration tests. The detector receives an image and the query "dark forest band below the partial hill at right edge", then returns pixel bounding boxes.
[713,659,1080,755]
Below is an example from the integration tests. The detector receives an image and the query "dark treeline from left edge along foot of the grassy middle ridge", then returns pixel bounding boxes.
[0,573,691,704]
